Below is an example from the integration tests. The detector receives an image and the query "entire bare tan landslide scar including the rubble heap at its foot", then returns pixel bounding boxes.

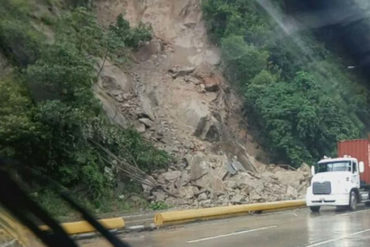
[95,0,309,207]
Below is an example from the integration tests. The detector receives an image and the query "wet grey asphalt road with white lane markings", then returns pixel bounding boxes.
[80,207,370,247]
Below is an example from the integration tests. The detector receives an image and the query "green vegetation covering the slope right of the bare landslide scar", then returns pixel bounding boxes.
[202,0,370,167]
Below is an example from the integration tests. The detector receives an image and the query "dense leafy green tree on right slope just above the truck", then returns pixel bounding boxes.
[245,72,359,166]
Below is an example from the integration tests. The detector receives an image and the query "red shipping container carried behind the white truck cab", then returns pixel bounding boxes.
[338,139,370,185]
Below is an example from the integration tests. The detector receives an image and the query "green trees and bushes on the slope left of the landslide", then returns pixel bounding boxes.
[0,0,170,213]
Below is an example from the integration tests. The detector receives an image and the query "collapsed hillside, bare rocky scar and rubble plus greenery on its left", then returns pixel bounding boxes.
[0,0,316,212]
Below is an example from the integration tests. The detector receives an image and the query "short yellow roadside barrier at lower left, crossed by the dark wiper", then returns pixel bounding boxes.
[40,217,125,234]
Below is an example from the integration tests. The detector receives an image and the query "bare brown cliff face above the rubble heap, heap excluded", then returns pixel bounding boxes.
[97,0,256,164]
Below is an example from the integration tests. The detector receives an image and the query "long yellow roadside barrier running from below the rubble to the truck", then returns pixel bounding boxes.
[154,200,306,226]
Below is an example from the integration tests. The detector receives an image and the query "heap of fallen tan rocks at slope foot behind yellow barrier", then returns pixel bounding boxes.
[143,152,310,208]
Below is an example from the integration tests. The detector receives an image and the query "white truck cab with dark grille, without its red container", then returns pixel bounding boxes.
[306,156,369,212]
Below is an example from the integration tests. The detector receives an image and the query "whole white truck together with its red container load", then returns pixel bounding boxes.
[306,140,370,212]
